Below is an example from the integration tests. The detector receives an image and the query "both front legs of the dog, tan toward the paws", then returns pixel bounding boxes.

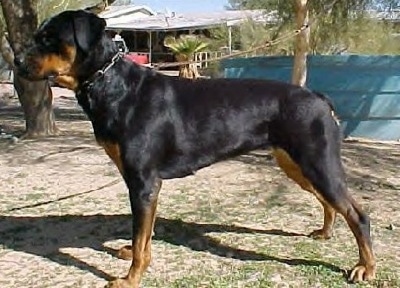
[106,170,161,288]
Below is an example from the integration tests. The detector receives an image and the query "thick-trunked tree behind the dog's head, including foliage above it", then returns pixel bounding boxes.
[0,0,113,138]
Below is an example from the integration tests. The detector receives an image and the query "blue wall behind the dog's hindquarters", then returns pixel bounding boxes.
[221,55,400,140]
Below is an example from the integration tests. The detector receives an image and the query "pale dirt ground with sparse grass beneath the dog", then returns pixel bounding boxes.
[0,84,400,288]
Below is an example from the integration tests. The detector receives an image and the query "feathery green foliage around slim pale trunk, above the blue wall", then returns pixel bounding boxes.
[228,0,400,54]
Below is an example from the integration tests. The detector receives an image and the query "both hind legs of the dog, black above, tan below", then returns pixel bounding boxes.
[273,144,376,282]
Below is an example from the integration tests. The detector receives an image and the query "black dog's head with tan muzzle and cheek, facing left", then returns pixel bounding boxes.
[15,10,106,89]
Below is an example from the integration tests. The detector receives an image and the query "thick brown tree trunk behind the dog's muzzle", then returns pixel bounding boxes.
[1,0,57,138]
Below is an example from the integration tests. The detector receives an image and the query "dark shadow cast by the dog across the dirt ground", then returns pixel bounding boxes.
[0,215,343,280]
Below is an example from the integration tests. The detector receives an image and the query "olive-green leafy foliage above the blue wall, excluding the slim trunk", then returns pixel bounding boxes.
[223,0,400,54]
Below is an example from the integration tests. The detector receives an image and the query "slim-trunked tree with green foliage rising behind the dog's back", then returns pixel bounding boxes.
[229,0,400,86]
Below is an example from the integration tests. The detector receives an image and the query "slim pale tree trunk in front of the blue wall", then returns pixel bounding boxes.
[292,0,310,86]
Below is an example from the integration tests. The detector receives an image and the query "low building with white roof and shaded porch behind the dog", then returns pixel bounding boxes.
[100,5,276,62]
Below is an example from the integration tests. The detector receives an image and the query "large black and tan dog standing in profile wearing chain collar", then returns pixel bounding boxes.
[16,11,376,287]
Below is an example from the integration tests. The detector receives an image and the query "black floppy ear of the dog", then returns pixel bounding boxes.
[72,10,106,53]
